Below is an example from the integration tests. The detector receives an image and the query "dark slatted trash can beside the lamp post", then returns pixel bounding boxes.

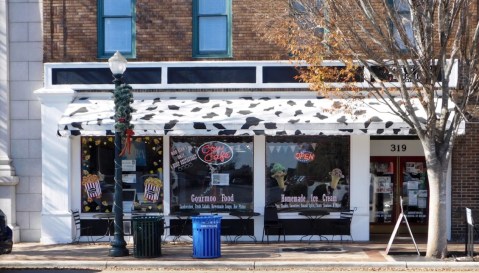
[131,216,164,258]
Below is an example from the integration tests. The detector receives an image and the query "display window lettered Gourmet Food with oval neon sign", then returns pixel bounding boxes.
[170,136,253,213]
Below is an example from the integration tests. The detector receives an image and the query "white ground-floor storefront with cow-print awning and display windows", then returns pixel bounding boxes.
[36,61,462,243]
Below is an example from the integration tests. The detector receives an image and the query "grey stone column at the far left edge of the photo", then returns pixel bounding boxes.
[0,0,20,242]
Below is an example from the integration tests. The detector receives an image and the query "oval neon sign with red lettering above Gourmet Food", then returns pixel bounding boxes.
[196,141,233,165]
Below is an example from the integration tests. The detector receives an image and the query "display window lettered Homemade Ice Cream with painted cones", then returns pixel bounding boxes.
[266,136,350,211]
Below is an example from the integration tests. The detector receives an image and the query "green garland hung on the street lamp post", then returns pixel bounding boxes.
[113,84,134,137]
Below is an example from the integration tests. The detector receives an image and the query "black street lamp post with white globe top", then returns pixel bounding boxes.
[108,51,129,257]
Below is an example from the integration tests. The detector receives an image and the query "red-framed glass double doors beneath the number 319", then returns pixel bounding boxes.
[369,156,429,234]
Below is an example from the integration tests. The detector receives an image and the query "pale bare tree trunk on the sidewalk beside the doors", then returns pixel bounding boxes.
[425,150,449,259]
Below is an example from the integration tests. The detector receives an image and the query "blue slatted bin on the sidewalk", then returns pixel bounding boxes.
[191,215,221,259]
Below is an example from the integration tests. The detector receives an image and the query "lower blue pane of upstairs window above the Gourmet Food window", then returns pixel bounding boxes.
[199,16,227,51]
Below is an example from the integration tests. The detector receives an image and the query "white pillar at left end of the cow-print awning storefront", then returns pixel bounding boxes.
[35,88,75,244]
